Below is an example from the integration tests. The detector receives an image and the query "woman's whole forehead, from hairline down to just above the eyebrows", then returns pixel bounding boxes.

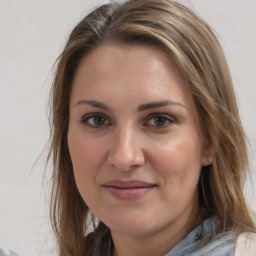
[73,45,189,103]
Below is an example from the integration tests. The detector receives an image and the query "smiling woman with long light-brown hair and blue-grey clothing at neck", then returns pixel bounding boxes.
[47,0,255,256]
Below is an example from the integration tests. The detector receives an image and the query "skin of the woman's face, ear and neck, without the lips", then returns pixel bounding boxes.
[68,45,212,256]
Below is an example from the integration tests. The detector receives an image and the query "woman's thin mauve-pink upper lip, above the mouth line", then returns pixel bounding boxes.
[103,180,156,189]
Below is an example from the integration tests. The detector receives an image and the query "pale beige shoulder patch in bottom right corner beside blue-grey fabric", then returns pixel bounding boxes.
[235,232,256,256]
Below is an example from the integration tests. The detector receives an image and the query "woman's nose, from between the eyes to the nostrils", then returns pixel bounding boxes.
[107,127,145,171]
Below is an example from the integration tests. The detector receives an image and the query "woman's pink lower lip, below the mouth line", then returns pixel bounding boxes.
[104,186,155,200]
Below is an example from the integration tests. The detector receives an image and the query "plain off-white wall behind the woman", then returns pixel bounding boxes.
[0,0,256,256]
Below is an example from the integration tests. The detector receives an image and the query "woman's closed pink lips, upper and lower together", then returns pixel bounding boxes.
[103,180,156,200]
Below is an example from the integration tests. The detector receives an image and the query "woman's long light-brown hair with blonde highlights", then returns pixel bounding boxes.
[49,0,255,256]
